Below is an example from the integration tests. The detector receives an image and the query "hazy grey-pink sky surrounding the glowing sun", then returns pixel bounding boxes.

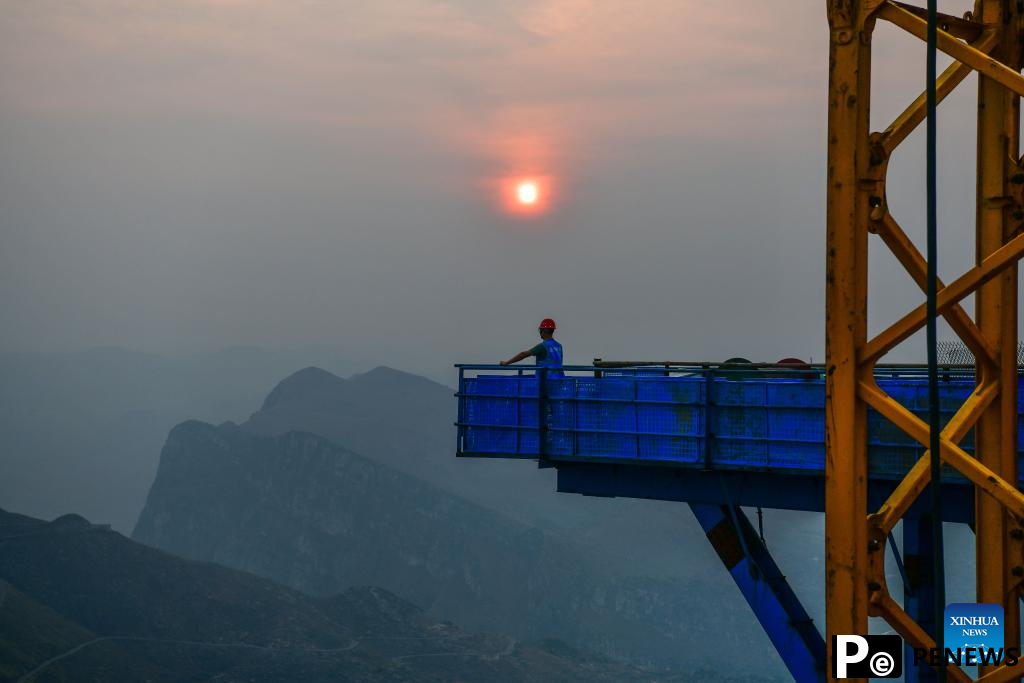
[0,0,1007,370]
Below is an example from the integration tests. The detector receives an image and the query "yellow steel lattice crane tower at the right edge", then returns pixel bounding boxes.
[825,0,1024,683]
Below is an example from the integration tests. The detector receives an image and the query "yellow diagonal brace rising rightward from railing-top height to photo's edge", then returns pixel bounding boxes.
[858,234,1024,365]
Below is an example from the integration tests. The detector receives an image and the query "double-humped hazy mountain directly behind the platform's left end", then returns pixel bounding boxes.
[242,367,729,573]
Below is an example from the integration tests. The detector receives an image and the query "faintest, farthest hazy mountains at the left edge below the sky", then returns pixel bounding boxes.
[0,348,367,533]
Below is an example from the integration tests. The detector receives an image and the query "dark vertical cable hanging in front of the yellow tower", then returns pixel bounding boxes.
[925,0,946,683]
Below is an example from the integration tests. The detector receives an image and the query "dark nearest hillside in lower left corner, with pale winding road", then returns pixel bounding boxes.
[0,510,704,683]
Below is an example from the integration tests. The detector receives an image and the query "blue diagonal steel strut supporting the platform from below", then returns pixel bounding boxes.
[690,503,825,683]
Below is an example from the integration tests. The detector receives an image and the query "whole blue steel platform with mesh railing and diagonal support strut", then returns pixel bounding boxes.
[457,365,1024,682]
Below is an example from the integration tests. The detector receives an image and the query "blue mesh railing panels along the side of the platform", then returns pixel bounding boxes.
[458,366,1024,479]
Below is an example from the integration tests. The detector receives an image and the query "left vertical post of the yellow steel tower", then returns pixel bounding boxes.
[825,0,873,680]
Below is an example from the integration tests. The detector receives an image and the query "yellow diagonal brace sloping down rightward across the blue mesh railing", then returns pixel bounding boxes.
[858,381,1024,520]
